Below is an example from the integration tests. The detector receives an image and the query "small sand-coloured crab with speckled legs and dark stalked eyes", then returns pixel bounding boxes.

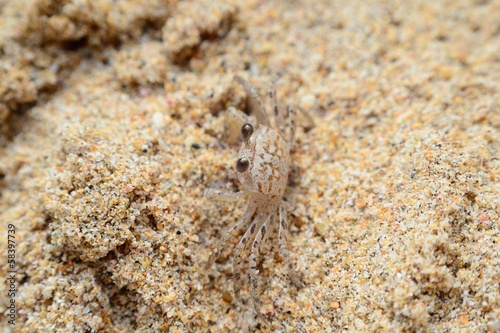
[205,76,303,324]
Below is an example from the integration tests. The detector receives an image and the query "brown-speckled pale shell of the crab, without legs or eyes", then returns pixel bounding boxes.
[238,125,289,198]
